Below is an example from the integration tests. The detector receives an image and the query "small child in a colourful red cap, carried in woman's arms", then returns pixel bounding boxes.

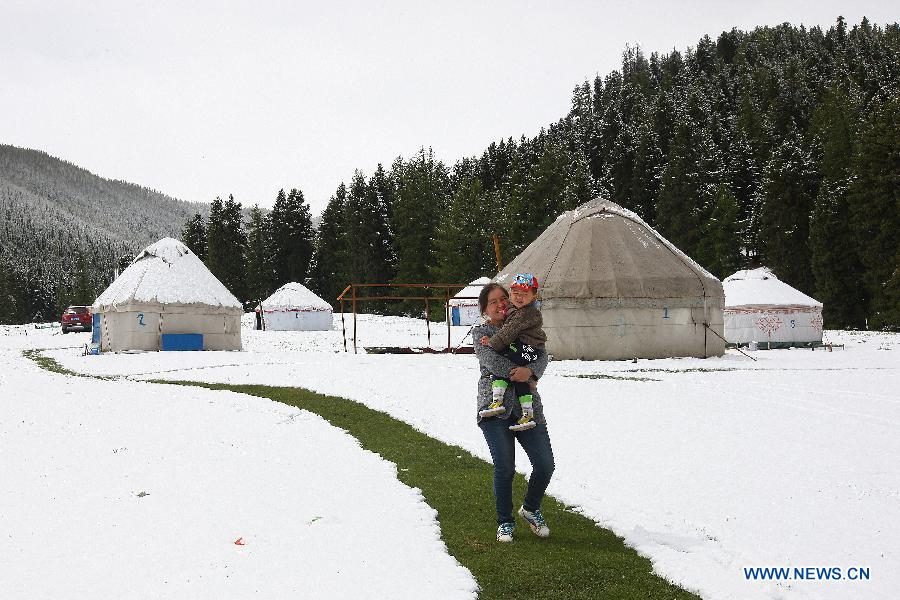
[478,273,547,431]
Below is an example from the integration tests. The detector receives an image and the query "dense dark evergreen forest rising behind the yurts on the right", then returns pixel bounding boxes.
[186,17,900,329]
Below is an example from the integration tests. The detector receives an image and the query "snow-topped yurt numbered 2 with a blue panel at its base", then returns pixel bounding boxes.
[92,238,243,352]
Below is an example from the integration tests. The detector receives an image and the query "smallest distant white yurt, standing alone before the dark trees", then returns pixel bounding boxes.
[256,282,332,331]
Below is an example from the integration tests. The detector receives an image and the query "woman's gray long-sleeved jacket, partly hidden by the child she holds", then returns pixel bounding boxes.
[472,323,550,423]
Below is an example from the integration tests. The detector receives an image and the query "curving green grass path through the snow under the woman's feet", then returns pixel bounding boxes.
[162,381,698,600]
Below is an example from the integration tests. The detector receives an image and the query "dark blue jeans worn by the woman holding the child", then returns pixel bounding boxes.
[478,419,554,523]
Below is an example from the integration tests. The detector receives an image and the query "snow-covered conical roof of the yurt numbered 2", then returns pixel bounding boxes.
[93,238,242,311]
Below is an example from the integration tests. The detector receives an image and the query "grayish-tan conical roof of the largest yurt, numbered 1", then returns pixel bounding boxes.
[495,198,723,299]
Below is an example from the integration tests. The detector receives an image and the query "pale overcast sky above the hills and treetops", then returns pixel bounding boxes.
[0,0,897,214]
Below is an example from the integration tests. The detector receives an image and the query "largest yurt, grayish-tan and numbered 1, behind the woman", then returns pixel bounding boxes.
[495,199,725,360]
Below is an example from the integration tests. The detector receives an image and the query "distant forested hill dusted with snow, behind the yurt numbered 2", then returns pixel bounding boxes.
[0,144,209,323]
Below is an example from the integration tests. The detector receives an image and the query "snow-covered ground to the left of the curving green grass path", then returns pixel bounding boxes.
[0,327,477,599]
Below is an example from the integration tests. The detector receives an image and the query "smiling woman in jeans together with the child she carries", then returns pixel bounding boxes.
[472,274,554,542]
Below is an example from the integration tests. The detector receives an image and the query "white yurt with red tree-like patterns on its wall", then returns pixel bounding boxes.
[722,267,822,348]
